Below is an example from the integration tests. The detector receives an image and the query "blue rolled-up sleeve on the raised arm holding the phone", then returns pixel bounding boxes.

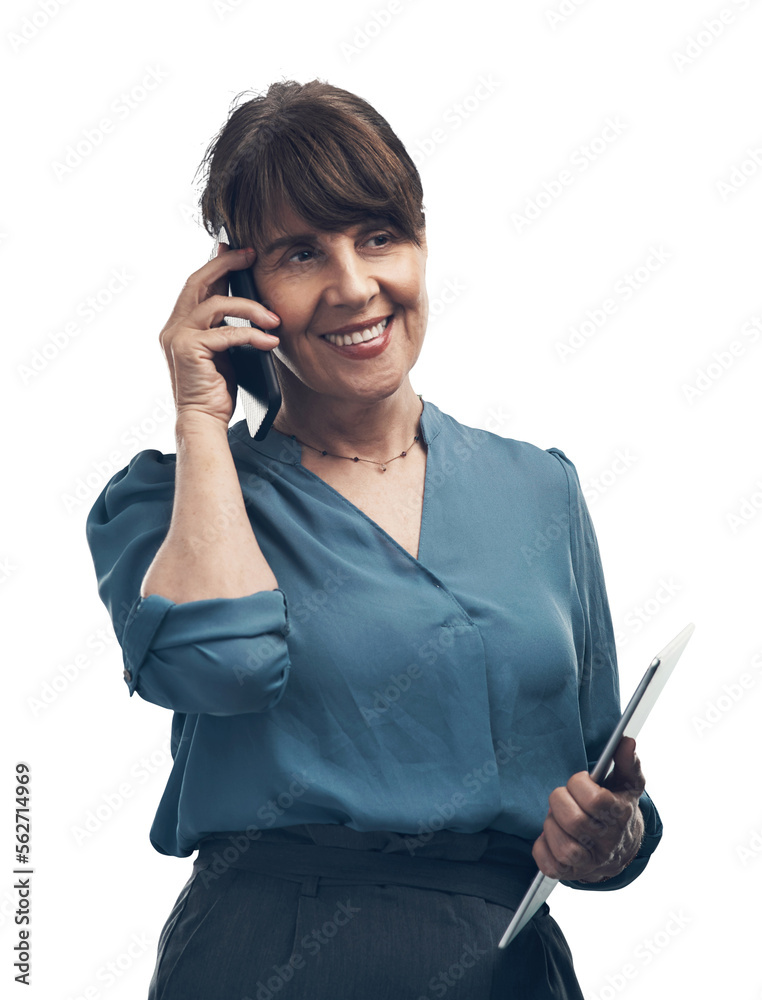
[86,449,291,715]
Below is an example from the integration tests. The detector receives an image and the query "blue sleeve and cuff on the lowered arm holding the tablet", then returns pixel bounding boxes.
[548,448,663,891]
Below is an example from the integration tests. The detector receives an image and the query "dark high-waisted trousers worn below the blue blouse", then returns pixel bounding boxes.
[148,825,583,1000]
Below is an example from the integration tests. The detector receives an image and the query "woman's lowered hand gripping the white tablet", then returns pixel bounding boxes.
[532,737,646,882]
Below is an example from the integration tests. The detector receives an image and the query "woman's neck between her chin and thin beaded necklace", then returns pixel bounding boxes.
[273,373,422,461]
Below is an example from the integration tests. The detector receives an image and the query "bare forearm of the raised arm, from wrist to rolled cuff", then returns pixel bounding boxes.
[140,412,278,604]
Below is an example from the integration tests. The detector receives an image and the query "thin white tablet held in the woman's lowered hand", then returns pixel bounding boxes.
[498,625,695,948]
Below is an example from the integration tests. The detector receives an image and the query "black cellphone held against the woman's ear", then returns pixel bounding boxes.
[217,227,282,441]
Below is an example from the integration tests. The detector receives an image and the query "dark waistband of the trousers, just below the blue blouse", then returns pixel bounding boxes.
[193,824,536,912]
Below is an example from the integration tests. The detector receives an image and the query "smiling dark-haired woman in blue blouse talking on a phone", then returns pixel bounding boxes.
[87,81,661,1000]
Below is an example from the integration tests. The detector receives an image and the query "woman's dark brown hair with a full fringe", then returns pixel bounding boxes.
[196,80,426,250]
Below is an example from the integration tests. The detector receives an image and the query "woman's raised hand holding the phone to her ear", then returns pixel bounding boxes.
[159,243,280,430]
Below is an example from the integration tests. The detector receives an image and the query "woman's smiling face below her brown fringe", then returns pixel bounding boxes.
[253,205,428,402]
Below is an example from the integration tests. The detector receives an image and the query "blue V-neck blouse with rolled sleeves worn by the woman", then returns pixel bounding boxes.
[87,401,662,889]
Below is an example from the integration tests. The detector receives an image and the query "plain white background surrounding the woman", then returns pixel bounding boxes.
[0,0,762,1000]
